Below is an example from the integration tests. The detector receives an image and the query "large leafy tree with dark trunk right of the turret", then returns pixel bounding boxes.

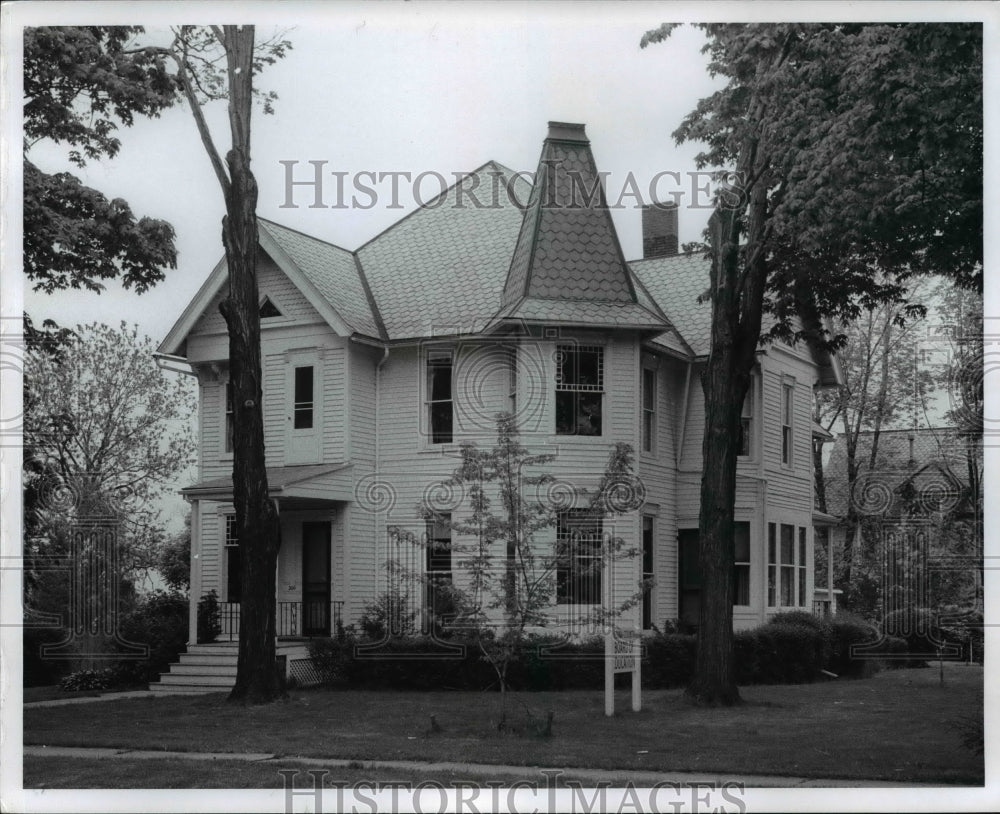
[641,24,983,704]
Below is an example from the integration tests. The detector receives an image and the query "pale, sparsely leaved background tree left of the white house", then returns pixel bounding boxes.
[24,323,195,571]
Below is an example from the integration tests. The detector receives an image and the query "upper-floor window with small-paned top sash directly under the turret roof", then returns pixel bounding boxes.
[556,345,604,435]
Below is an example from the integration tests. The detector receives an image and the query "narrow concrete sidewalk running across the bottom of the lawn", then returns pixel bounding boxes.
[24,744,936,788]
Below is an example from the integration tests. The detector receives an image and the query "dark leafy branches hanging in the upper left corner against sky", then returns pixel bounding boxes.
[24,26,178,293]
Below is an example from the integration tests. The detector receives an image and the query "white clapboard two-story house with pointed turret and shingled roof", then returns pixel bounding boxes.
[159,123,840,656]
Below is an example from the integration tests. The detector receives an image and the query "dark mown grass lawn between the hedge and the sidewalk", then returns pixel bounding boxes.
[24,664,984,786]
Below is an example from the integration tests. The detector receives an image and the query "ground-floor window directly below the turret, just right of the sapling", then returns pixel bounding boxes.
[556,509,603,605]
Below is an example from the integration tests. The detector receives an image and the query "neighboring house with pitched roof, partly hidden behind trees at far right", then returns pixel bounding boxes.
[823,427,983,616]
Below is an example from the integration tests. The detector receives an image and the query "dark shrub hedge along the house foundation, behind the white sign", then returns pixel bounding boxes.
[310,612,906,690]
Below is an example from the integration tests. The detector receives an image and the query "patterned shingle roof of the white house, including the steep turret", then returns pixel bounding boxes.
[166,122,828,357]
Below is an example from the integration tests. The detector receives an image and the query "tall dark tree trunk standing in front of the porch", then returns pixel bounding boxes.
[219,26,284,704]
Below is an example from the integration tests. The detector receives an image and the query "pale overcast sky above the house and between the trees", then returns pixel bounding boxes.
[15,3,721,341]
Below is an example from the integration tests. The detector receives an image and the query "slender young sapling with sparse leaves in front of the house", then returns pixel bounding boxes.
[389,413,648,730]
